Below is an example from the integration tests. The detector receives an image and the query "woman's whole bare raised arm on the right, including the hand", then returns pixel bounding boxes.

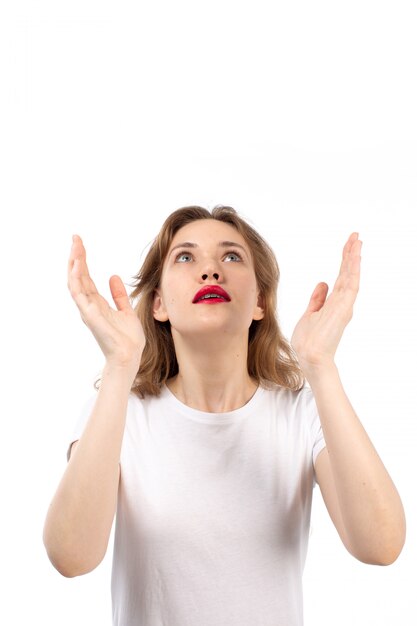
[292,233,405,565]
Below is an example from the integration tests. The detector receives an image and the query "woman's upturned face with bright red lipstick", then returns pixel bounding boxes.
[154,219,263,337]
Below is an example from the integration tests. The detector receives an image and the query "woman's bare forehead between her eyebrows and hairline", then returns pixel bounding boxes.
[170,219,249,246]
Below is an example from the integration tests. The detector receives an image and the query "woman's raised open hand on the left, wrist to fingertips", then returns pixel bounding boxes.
[68,235,146,374]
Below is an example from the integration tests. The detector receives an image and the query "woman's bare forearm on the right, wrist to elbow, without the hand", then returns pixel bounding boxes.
[307,365,405,562]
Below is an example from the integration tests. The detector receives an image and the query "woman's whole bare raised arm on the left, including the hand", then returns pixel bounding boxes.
[43,236,145,576]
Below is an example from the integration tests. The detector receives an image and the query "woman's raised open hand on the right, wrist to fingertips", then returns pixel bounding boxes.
[291,233,362,376]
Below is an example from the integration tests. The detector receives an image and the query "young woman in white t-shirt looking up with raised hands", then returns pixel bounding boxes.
[44,206,405,626]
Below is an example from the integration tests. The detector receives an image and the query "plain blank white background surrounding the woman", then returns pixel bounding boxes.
[0,0,417,626]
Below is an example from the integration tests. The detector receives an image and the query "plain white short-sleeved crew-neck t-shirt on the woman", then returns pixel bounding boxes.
[71,386,325,626]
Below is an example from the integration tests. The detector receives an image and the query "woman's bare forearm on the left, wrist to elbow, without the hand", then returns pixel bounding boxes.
[44,365,133,576]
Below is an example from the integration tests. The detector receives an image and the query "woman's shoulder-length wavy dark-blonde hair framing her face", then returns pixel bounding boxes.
[95,205,305,398]
